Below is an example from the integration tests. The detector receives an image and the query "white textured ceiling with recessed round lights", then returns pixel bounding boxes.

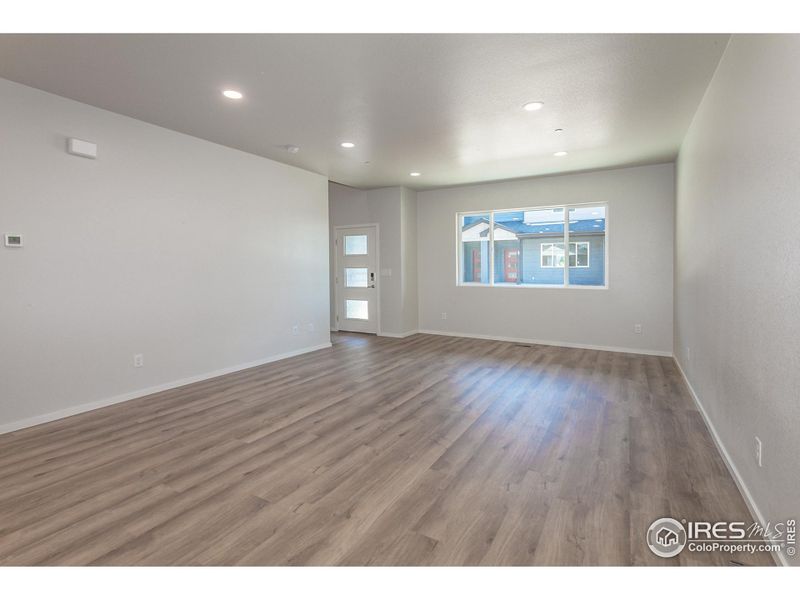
[0,34,728,189]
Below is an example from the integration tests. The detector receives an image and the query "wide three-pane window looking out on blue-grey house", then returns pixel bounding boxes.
[458,204,608,287]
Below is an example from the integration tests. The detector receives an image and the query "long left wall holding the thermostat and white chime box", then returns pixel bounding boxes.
[0,80,329,430]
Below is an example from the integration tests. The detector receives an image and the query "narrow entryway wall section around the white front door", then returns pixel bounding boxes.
[329,182,417,335]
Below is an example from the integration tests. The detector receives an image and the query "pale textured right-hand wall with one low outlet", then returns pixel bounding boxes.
[675,35,800,564]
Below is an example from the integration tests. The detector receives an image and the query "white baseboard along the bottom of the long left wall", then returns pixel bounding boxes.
[0,342,331,434]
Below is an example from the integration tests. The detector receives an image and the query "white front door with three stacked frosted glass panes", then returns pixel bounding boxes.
[336,225,378,333]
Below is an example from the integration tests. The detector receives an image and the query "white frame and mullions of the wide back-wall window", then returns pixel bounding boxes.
[455,202,610,290]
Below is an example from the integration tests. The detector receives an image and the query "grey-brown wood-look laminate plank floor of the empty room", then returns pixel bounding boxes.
[0,334,772,565]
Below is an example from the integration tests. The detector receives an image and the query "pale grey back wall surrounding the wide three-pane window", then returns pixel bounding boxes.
[417,164,675,355]
